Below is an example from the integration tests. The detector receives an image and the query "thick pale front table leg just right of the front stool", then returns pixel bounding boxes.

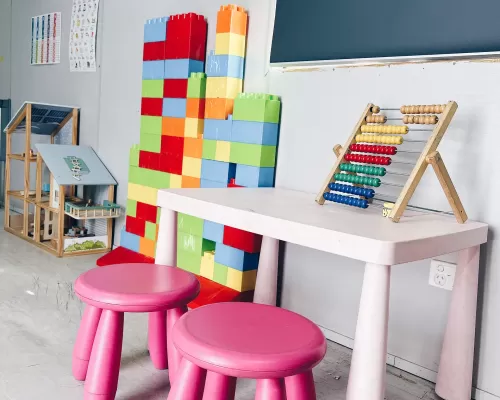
[346,263,391,400]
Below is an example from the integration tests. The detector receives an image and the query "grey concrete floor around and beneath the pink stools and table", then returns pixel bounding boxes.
[0,210,438,400]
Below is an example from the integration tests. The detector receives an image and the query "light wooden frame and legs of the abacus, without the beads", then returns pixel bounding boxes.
[316,101,468,224]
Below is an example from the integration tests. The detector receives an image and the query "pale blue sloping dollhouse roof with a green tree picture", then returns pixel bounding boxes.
[36,143,117,186]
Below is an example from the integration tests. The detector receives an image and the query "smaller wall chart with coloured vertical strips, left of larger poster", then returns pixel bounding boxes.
[31,12,61,65]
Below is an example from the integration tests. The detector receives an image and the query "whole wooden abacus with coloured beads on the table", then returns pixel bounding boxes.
[316,101,467,223]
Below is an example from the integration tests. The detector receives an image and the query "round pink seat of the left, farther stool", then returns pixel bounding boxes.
[75,264,200,312]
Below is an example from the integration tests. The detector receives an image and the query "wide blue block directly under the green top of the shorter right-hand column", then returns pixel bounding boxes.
[231,121,279,146]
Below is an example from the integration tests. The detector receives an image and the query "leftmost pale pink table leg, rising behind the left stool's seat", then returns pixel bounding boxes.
[155,208,177,267]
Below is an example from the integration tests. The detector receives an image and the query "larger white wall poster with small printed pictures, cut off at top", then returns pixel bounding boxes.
[69,0,99,72]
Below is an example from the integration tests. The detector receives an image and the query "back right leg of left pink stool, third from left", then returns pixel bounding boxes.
[148,311,168,369]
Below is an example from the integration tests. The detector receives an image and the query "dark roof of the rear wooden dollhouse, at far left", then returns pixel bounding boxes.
[5,101,79,135]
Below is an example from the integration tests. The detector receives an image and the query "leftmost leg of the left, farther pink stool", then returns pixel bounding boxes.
[73,306,102,381]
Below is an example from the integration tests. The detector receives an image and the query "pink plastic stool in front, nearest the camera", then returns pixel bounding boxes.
[168,303,326,400]
